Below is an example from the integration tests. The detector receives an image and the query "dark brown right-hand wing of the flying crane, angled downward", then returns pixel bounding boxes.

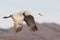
[24,15,38,31]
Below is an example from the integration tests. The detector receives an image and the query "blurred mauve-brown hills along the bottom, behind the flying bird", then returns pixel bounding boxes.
[0,23,60,40]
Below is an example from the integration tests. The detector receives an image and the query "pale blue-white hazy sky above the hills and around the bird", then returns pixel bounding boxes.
[0,0,60,28]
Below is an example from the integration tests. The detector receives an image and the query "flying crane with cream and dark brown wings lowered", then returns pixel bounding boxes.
[3,11,42,32]
